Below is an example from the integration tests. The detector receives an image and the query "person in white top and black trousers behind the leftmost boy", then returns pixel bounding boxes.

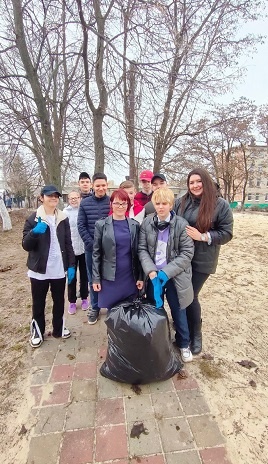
[64,190,89,314]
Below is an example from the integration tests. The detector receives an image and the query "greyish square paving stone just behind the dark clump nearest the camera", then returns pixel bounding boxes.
[124,395,154,422]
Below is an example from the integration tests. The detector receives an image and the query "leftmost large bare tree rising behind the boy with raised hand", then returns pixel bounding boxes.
[0,0,88,188]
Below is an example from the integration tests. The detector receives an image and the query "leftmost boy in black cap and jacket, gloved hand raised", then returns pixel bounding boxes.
[22,185,75,348]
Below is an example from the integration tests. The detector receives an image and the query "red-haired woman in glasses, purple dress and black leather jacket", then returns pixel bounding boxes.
[92,189,143,309]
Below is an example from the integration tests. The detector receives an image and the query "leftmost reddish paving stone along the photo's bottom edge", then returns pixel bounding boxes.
[60,428,93,464]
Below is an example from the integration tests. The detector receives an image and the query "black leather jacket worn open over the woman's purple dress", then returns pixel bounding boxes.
[92,215,143,284]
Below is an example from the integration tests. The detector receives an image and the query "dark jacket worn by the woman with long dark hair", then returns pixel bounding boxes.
[174,196,233,274]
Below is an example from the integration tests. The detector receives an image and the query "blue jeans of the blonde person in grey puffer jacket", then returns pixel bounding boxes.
[146,279,190,348]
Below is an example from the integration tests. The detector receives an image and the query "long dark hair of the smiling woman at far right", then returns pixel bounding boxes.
[181,168,218,233]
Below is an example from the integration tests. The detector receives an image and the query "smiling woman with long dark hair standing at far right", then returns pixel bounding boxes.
[174,168,233,354]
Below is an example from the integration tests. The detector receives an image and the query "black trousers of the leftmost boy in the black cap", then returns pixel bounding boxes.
[30,277,66,337]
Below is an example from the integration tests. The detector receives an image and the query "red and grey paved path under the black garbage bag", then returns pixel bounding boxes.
[27,309,231,464]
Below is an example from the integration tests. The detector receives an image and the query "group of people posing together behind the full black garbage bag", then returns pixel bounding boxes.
[22,168,233,362]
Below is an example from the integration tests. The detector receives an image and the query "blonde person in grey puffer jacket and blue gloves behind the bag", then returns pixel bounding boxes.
[138,187,194,362]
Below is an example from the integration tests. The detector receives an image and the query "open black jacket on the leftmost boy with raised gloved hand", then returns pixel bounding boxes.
[22,206,75,274]
